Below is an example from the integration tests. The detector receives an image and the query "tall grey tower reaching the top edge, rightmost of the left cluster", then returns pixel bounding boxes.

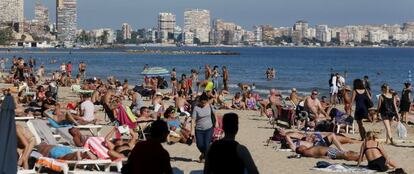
[56,0,77,47]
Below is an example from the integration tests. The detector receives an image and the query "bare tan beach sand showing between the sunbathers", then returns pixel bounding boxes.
[8,84,414,174]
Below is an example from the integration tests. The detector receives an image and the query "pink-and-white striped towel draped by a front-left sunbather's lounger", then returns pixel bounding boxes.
[83,137,109,159]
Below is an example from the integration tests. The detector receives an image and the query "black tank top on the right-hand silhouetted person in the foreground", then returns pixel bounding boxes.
[208,140,245,174]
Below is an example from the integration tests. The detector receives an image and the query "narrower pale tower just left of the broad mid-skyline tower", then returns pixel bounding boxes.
[158,13,175,43]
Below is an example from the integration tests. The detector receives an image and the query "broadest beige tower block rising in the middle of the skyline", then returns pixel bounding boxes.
[184,9,211,43]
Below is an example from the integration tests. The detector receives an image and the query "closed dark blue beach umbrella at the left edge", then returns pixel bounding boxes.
[0,94,17,174]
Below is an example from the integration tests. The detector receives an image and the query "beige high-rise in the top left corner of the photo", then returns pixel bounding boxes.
[0,0,24,32]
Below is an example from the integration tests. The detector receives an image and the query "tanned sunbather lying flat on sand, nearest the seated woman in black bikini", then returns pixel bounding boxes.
[296,146,359,161]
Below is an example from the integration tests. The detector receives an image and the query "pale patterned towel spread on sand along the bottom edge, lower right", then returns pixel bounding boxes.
[312,164,375,173]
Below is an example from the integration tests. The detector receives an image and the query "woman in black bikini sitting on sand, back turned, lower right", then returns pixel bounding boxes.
[358,131,397,172]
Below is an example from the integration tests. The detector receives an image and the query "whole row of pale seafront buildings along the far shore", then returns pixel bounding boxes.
[0,0,414,47]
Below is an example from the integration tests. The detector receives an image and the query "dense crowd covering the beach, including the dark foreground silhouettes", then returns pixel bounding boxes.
[0,57,412,173]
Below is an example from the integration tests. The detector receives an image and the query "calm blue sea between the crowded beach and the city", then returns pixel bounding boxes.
[0,48,414,97]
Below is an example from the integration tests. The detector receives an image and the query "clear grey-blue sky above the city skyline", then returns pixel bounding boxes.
[25,0,414,30]
